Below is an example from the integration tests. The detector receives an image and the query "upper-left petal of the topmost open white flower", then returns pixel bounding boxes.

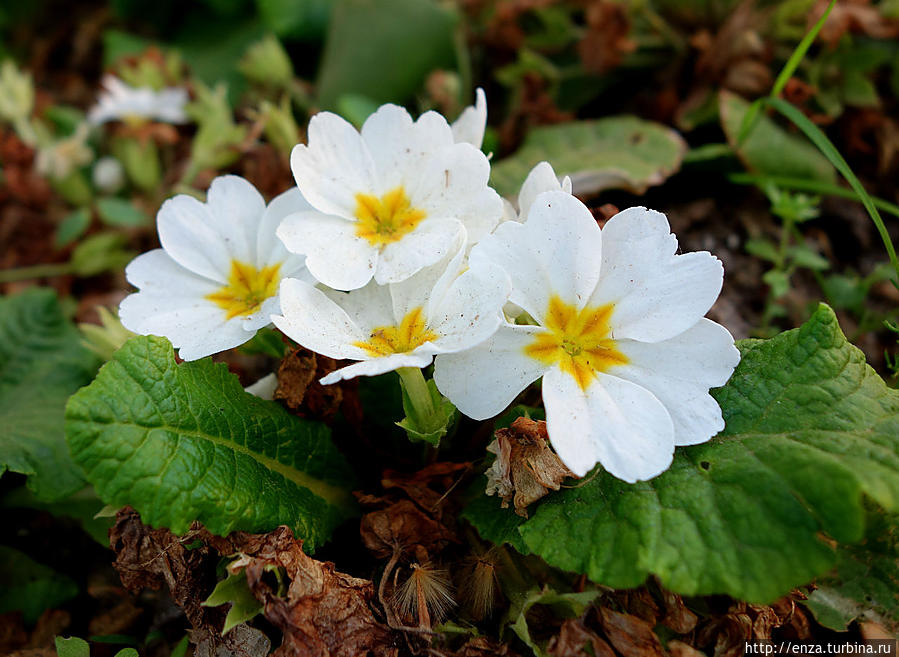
[290,112,376,217]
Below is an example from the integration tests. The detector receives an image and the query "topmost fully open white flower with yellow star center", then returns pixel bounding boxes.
[278,105,502,290]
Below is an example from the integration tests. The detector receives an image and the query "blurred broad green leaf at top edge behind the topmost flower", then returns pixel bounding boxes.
[318,0,458,109]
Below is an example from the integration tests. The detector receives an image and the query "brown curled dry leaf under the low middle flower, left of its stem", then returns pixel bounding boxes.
[274,347,343,419]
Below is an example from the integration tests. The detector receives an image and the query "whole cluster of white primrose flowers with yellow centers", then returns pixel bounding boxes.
[121,90,739,482]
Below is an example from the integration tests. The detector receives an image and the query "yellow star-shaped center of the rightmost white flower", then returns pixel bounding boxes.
[524,296,628,390]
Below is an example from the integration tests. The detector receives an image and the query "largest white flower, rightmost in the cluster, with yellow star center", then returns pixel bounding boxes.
[434,191,739,482]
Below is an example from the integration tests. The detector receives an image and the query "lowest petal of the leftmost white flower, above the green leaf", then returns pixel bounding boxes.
[119,292,255,360]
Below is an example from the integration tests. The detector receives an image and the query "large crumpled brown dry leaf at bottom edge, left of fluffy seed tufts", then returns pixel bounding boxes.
[236,527,397,657]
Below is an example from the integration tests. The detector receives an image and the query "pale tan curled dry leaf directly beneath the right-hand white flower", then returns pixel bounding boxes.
[487,417,574,518]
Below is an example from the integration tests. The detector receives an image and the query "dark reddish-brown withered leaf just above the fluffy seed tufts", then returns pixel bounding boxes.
[359,500,456,559]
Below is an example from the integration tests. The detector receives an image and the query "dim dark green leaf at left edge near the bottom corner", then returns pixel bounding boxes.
[0,545,78,625]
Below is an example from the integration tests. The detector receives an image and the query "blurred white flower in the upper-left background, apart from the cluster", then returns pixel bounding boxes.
[87,75,188,124]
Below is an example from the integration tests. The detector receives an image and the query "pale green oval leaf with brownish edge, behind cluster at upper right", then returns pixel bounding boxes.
[491,116,687,196]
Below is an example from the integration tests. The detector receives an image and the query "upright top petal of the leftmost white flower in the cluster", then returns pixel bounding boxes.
[206,176,265,266]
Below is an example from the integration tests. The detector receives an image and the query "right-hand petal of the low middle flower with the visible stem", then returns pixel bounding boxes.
[428,263,511,352]
